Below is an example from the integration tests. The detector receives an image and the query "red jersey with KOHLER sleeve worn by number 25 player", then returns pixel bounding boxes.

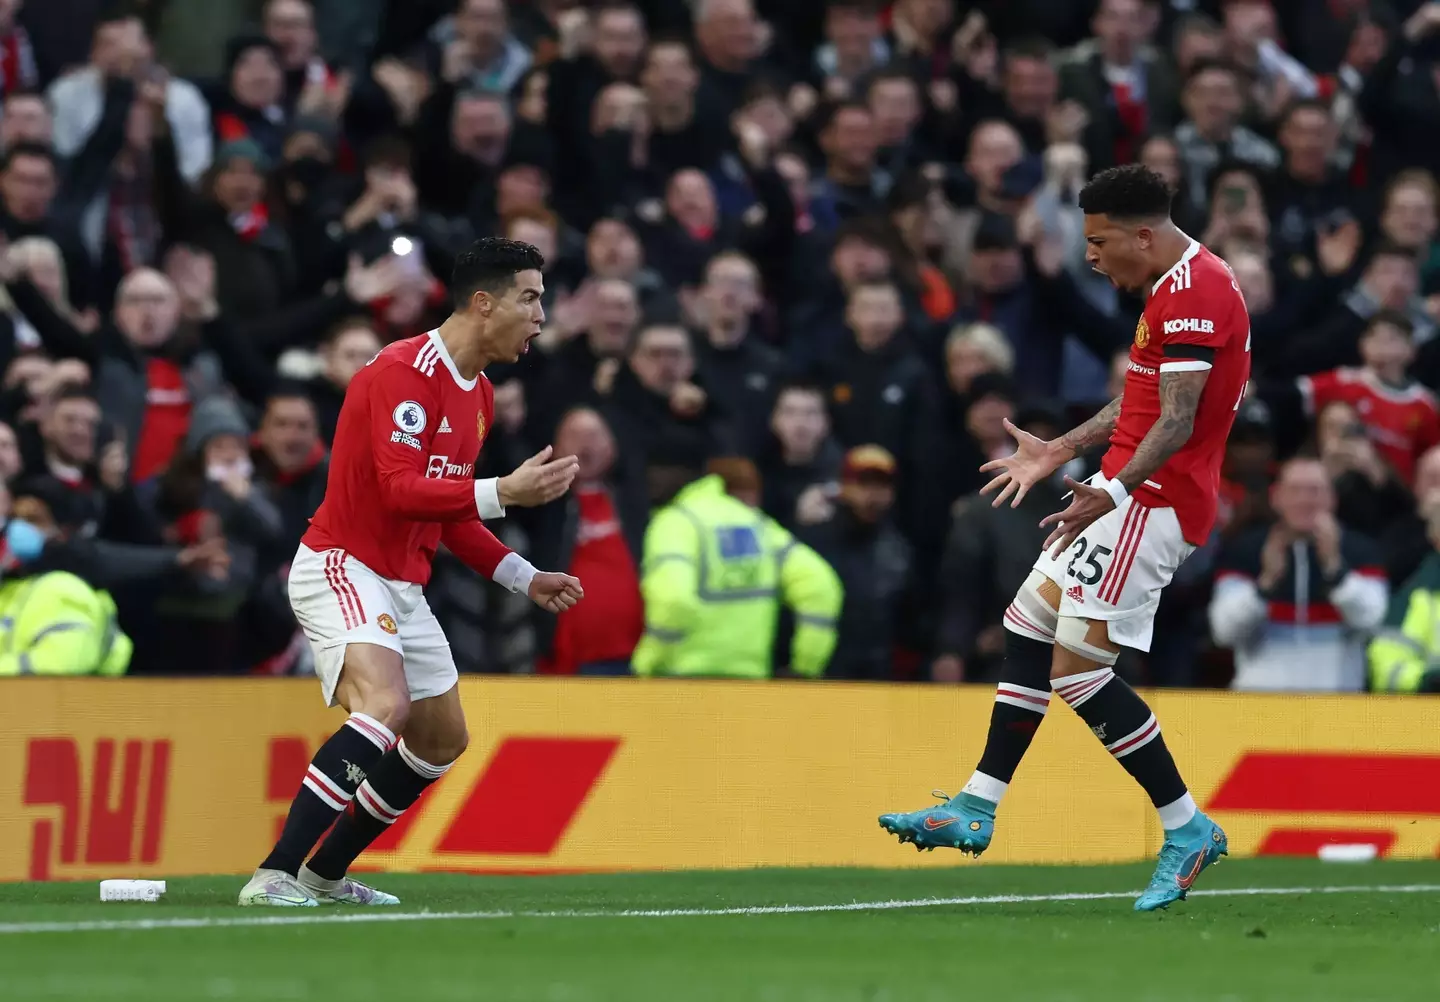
[1100,242,1250,546]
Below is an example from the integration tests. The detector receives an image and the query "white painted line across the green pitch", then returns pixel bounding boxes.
[0,884,1440,936]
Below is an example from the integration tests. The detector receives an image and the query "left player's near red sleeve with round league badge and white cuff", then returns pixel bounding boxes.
[366,364,498,523]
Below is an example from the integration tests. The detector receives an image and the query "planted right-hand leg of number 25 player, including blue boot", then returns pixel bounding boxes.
[1050,616,1227,911]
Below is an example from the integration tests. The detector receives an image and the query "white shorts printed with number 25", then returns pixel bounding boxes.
[1034,474,1195,651]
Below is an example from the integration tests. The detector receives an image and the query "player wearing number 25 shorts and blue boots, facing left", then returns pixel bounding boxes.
[880,164,1250,911]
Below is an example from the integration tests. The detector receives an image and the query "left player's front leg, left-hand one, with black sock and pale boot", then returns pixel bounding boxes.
[240,644,410,907]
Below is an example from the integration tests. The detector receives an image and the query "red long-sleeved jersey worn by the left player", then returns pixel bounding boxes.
[302,331,510,585]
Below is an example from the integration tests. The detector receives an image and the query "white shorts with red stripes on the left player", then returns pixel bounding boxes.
[289,544,459,707]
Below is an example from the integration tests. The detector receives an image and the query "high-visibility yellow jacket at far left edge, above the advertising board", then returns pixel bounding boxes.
[0,570,134,677]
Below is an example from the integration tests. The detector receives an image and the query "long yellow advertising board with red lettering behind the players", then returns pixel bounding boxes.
[0,678,1440,881]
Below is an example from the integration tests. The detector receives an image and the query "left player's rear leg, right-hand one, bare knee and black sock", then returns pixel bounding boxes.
[301,685,469,904]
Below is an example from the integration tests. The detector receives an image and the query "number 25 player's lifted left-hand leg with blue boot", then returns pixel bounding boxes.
[880,570,1060,855]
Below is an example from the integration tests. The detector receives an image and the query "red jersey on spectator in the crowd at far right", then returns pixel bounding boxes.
[1299,369,1440,484]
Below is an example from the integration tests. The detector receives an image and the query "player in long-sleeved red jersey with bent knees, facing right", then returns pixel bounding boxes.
[240,239,583,907]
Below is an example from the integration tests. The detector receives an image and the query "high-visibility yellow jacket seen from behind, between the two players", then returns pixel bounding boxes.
[632,477,845,678]
